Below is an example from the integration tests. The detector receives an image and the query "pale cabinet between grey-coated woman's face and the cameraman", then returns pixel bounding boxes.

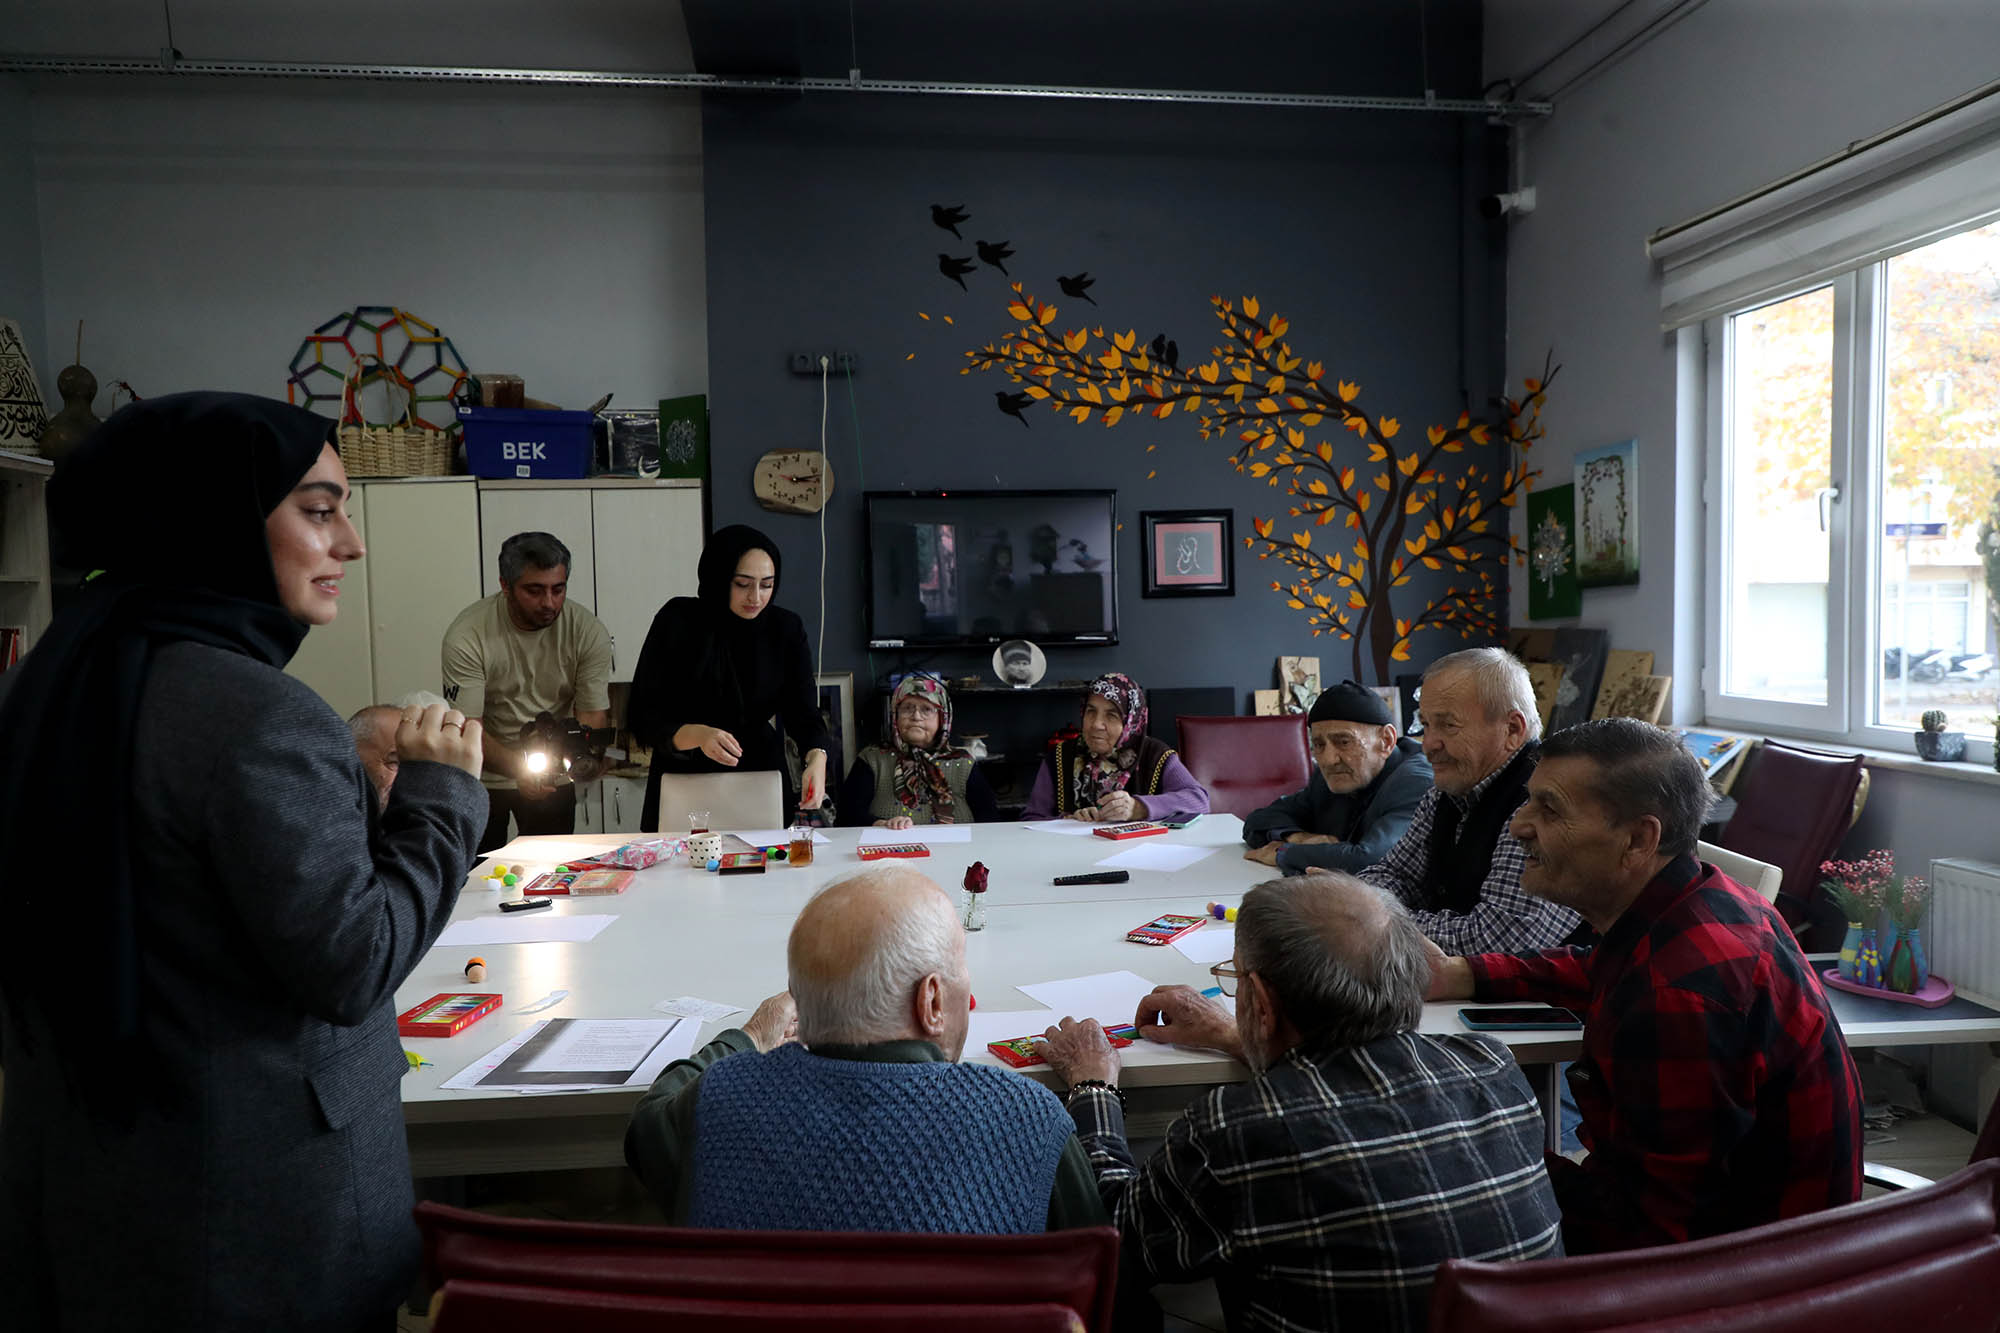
[286,476,480,717]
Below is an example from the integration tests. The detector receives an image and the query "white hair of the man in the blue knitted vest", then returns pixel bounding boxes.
[786,865,964,1047]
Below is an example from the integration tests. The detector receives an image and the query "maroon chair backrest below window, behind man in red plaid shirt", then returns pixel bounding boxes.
[1716,741,1864,933]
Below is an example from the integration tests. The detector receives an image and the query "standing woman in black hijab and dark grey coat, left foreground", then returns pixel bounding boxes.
[0,394,486,1331]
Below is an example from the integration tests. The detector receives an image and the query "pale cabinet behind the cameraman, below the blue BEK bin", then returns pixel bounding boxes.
[480,478,706,681]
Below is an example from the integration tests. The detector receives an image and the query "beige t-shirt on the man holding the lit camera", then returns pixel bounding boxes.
[444,592,612,787]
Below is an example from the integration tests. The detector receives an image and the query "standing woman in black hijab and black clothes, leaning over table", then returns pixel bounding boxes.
[628,524,826,833]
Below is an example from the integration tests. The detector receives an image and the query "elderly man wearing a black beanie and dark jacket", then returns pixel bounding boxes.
[1244,681,1432,875]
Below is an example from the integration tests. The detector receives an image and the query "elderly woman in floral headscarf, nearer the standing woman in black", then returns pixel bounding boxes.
[840,671,1000,829]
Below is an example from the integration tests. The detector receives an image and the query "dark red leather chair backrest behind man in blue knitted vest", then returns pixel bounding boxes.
[416,1203,1118,1333]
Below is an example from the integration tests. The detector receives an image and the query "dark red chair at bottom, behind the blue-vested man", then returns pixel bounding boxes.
[416,1201,1118,1333]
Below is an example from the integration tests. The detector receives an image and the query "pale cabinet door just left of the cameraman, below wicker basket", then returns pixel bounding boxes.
[362,476,482,703]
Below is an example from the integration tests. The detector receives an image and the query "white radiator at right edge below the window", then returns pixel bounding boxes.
[1924,859,2000,1129]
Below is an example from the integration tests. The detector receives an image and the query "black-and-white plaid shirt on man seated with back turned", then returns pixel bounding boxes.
[1070,1033,1562,1333]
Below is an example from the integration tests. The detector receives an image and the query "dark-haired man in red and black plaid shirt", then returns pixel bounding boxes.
[1430,719,1862,1253]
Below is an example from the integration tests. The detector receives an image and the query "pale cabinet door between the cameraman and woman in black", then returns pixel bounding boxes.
[590,486,704,681]
